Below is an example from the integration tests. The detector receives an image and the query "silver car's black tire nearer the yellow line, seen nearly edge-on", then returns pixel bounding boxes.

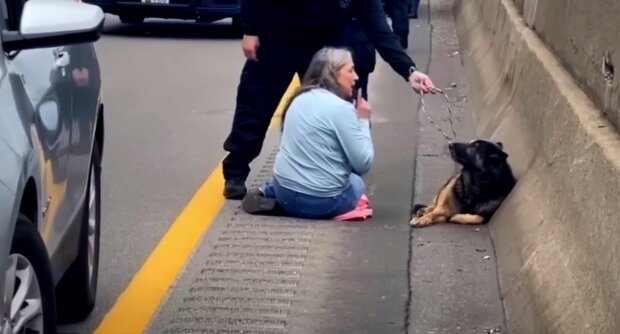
[56,143,101,324]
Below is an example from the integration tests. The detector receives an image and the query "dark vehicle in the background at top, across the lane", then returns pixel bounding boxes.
[84,0,241,30]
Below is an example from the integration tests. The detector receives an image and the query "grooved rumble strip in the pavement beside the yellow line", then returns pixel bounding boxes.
[163,150,314,334]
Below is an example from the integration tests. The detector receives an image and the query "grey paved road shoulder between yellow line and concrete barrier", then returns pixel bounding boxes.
[149,0,503,334]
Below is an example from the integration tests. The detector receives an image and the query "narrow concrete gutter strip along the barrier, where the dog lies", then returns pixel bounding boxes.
[408,0,506,334]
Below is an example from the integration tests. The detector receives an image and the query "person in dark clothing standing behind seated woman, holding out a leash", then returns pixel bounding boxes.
[223,0,434,199]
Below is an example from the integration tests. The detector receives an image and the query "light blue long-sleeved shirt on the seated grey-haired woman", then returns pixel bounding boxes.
[273,89,374,197]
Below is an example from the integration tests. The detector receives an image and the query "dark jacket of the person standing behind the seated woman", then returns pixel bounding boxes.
[241,0,415,80]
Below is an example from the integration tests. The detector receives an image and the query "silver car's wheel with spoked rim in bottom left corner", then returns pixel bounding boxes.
[0,215,56,334]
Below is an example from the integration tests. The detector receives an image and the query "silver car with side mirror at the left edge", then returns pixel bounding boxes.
[0,0,104,334]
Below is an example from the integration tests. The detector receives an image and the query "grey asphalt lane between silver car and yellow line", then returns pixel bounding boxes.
[59,16,244,333]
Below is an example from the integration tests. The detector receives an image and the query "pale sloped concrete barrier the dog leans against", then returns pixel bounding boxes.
[454,0,620,334]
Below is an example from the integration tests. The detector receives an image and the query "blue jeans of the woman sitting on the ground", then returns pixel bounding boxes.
[261,174,365,219]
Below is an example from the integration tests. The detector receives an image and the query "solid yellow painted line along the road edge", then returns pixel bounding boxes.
[95,76,299,334]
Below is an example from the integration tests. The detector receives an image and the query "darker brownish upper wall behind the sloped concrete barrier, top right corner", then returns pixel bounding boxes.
[515,0,620,129]
